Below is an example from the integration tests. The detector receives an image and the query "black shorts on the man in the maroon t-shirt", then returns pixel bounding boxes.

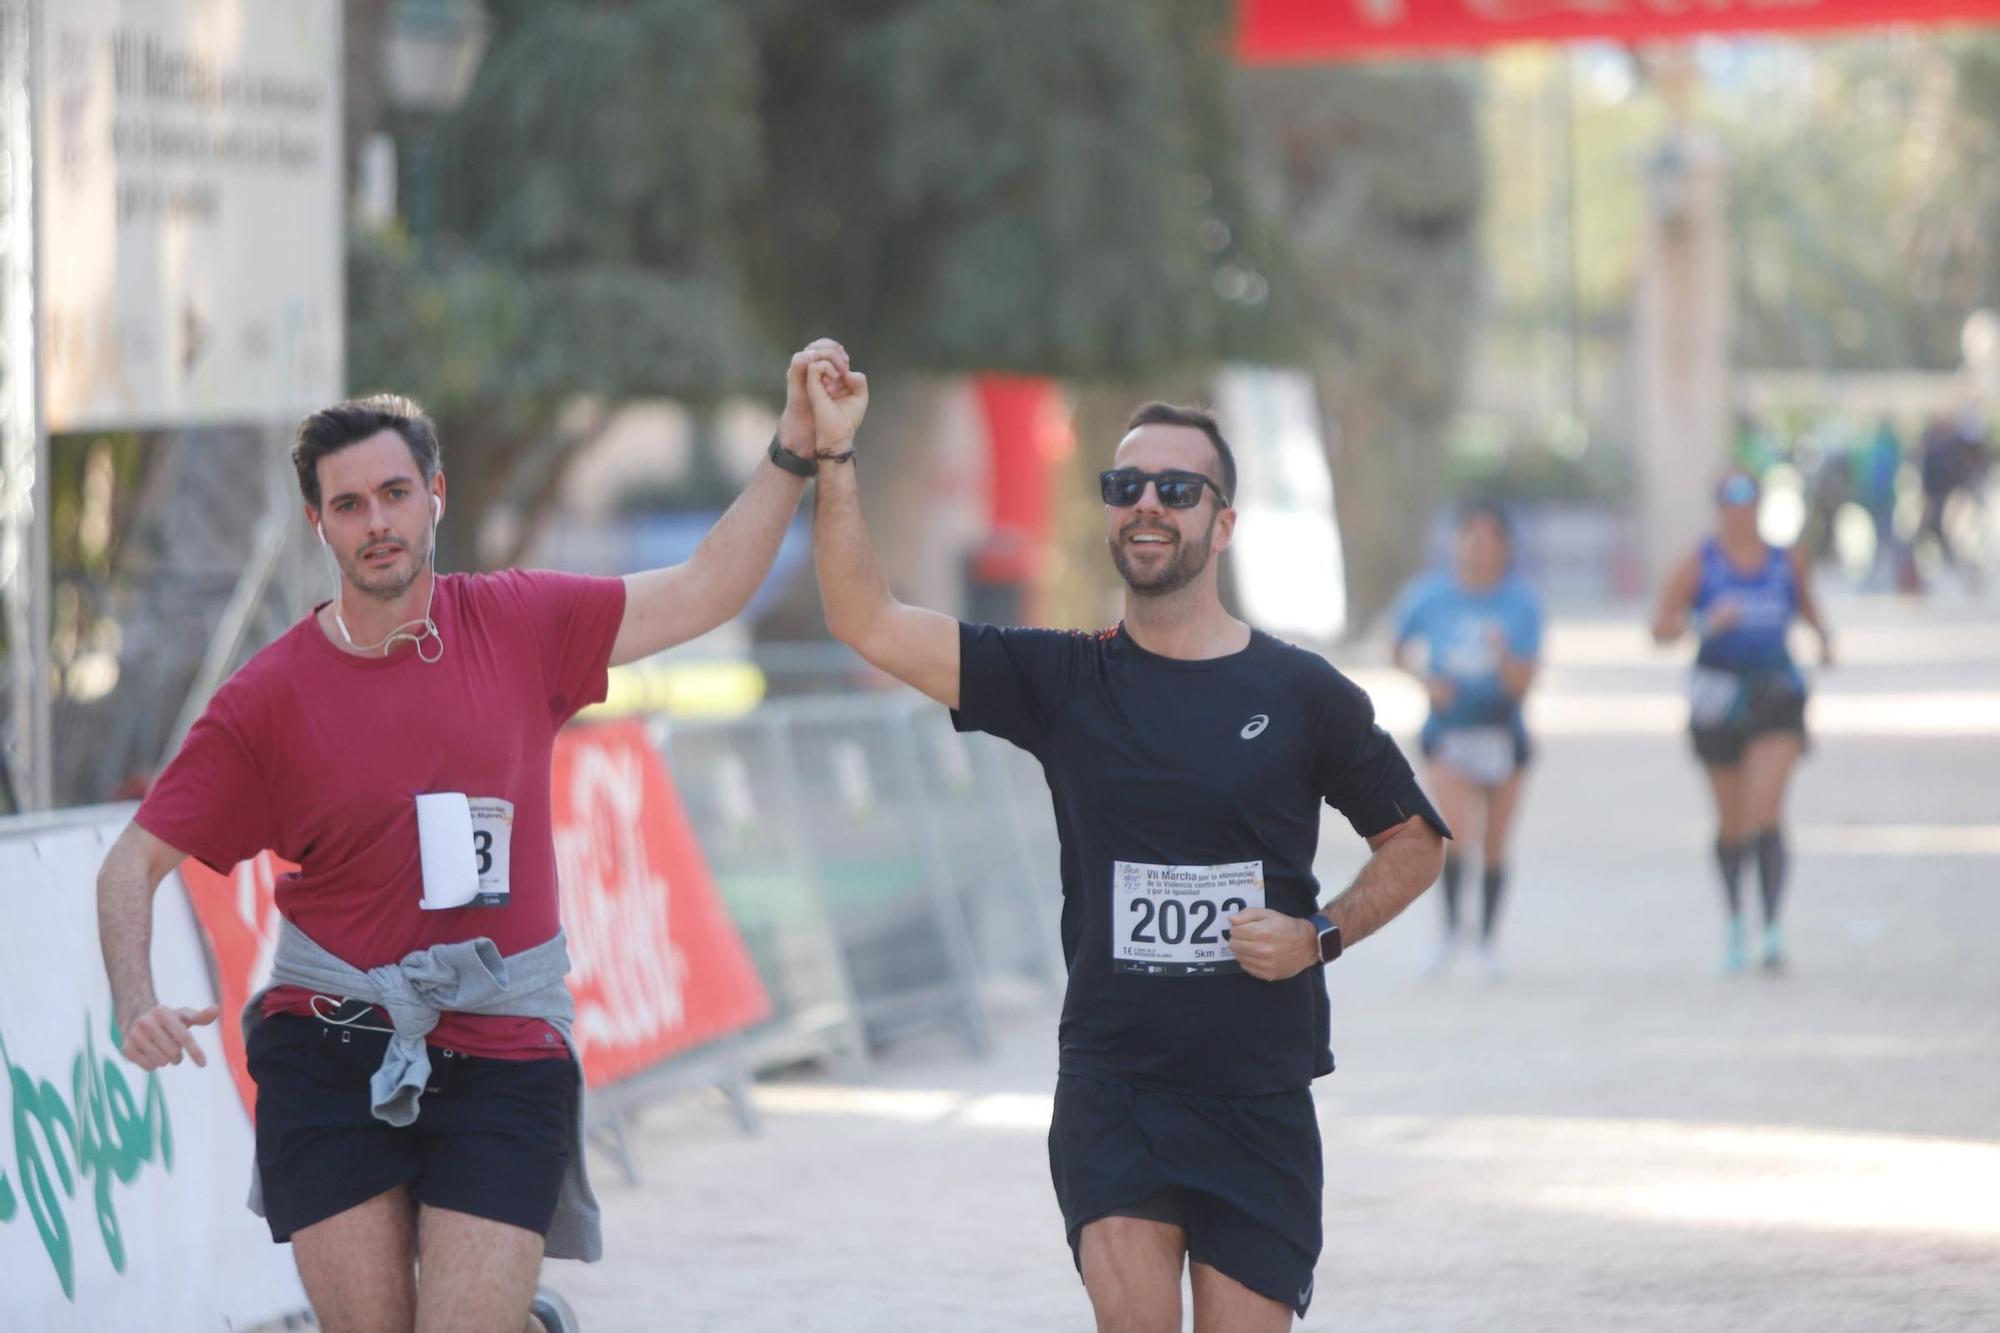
[248,1013,578,1241]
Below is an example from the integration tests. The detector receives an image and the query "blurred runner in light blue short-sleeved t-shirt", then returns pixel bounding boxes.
[1396,502,1542,977]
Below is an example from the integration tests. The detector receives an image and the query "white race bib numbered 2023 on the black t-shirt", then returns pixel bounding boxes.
[1112,861,1264,977]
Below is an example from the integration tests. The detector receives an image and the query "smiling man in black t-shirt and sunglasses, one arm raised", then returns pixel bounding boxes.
[808,362,1450,1333]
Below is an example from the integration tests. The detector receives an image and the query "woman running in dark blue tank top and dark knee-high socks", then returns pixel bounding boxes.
[1652,472,1834,973]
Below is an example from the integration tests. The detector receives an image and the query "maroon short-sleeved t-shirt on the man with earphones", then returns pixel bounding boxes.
[138,570,624,1057]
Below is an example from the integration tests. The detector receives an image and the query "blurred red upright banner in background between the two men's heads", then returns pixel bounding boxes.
[972,374,1068,584]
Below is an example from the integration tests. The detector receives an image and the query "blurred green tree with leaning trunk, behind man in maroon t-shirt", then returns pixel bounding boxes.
[348,0,782,568]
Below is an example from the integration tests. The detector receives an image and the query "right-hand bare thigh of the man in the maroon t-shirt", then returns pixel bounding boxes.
[416,1207,542,1333]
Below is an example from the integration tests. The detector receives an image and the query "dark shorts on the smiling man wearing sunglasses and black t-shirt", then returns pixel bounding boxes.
[1048,1075,1324,1315]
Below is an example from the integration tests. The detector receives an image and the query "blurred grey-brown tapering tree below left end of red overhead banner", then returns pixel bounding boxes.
[1246,64,1484,630]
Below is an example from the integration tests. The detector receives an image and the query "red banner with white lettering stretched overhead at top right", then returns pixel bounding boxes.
[1236,0,2000,64]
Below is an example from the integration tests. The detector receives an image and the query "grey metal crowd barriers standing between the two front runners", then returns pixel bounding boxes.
[654,691,1062,1069]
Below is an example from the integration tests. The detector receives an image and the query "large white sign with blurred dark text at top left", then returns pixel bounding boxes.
[36,0,344,432]
